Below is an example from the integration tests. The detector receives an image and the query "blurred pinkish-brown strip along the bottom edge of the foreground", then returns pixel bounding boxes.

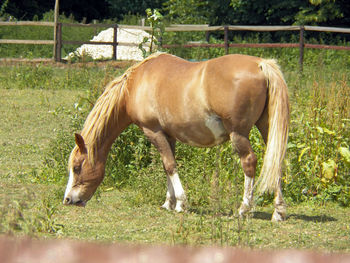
[0,236,350,263]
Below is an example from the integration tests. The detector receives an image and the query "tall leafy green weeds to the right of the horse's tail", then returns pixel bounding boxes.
[285,69,350,208]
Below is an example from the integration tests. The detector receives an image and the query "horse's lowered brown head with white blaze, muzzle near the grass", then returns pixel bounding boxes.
[63,134,104,206]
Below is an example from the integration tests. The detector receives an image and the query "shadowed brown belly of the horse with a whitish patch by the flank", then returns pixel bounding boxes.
[169,114,229,147]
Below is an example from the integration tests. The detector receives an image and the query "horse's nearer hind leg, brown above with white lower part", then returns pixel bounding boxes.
[230,132,257,219]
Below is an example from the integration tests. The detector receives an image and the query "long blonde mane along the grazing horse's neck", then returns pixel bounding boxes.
[70,52,164,164]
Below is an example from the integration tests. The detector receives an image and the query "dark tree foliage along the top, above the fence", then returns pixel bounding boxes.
[0,0,350,27]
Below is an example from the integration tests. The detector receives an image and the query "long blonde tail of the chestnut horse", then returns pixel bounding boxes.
[257,59,289,196]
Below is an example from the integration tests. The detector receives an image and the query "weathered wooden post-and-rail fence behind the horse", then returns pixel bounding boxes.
[0,21,350,70]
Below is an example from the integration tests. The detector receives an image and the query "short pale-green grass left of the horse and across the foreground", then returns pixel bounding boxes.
[0,58,350,252]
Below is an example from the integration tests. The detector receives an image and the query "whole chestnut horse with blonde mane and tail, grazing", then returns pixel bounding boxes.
[63,53,289,221]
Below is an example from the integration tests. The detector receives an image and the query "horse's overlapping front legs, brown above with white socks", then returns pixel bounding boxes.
[143,128,186,212]
